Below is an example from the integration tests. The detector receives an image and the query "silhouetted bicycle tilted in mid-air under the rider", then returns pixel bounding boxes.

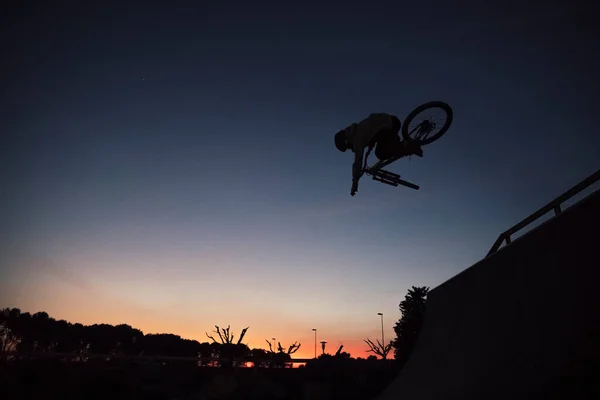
[361,101,454,190]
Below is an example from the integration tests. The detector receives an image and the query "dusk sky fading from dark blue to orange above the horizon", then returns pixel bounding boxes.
[0,1,600,357]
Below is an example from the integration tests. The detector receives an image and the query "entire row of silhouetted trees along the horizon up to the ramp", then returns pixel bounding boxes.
[0,287,428,367]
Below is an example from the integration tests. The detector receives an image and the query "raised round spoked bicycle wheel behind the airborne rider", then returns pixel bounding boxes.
[402,101,454,146]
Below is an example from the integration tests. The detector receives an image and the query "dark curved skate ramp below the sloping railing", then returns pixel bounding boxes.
[379,191,600,400]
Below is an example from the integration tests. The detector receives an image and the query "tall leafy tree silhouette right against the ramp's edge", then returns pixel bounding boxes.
[393,286,429,365]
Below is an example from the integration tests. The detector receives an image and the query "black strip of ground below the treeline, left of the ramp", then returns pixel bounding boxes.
[0,359,404,400]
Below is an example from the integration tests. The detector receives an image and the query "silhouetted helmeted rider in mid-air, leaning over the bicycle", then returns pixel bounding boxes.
[335,113,423,196]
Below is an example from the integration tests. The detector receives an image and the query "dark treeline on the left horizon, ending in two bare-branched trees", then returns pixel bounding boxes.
[0,308,299,365]
